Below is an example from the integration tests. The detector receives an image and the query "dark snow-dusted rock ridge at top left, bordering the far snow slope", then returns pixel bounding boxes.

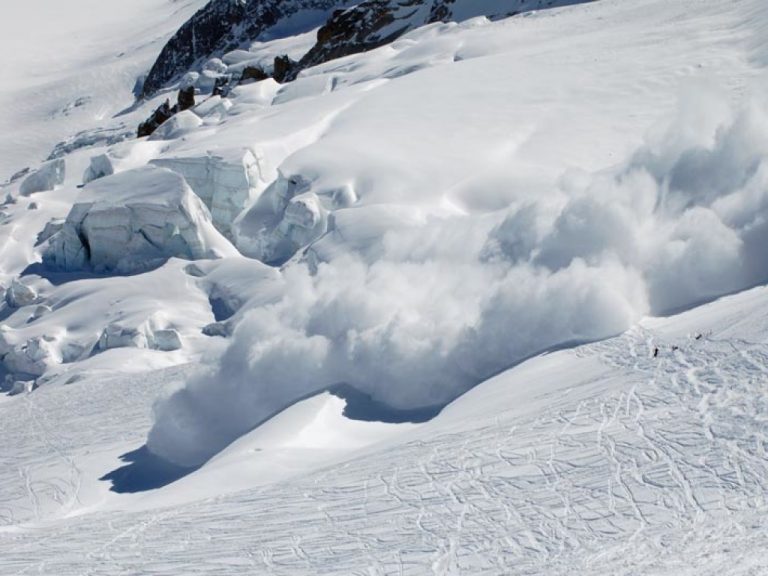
[141,0,351,97]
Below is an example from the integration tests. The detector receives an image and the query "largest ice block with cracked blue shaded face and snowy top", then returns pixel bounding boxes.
[43,167,234,274]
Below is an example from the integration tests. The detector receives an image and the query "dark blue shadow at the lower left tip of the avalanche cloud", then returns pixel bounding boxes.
[99,445,199,494]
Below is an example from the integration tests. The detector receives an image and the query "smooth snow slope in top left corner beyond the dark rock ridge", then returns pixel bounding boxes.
[0,0,205,181]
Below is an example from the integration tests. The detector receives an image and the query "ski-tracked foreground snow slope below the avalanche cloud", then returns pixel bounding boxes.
[0,288,768,575]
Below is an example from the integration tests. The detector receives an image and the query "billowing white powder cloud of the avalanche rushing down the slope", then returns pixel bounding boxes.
[148,94,768,466]
